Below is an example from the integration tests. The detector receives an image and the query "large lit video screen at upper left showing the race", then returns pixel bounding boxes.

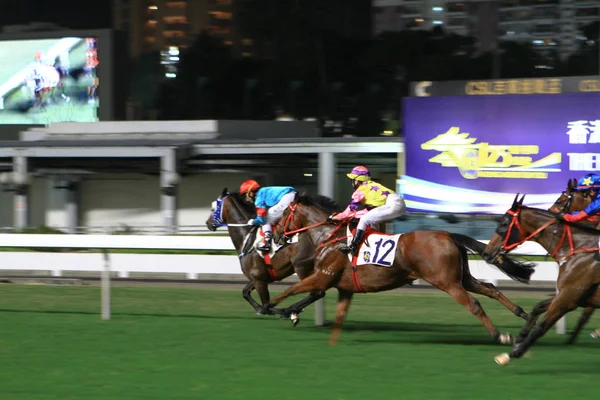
[0,37,99,125]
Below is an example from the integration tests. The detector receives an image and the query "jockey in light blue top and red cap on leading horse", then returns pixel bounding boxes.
[240,179,296,251]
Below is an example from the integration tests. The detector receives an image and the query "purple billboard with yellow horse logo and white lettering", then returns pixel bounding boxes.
[398,93,600,214]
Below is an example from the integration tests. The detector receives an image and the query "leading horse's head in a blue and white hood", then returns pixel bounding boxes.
[206,188,255,232]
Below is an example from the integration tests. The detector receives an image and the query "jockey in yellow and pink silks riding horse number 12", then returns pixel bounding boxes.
[327,165,406,255]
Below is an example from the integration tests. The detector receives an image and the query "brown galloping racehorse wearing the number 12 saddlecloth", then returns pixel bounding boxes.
[270,196,533,344]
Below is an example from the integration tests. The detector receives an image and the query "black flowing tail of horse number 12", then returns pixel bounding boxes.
[450,233,535,283]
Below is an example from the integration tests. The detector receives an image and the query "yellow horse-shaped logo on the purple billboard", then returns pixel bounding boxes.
[421,126,561,179]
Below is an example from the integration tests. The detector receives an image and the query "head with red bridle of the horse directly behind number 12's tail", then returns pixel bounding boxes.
[483,194,526,260]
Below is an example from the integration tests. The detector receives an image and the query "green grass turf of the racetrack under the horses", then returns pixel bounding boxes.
[0,285,600,400]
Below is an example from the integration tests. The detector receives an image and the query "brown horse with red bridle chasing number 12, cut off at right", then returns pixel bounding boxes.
[484,196,600,365]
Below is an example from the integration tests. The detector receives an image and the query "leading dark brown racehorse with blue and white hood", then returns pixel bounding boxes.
[206,188,339,326]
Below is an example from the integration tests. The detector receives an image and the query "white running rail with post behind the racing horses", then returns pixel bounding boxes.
[0,234,565,333]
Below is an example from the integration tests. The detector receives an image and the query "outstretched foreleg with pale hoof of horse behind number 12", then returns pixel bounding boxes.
[494,286,589,365]
